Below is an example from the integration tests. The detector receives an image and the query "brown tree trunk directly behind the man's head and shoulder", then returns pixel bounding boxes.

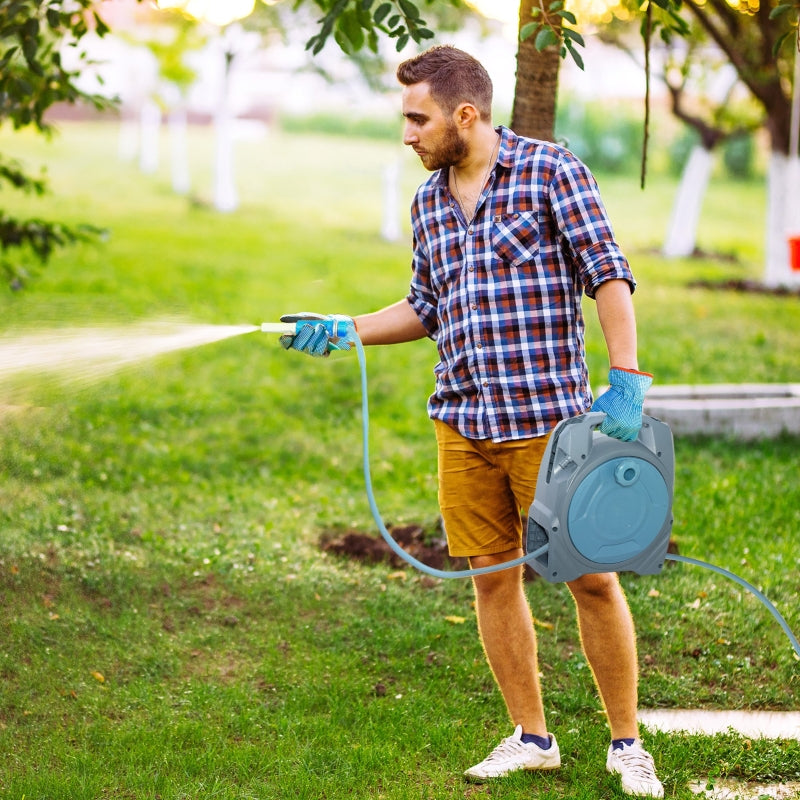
[511,0,561,142]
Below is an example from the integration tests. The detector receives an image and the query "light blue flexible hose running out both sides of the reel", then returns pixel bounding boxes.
[355,334,800,659]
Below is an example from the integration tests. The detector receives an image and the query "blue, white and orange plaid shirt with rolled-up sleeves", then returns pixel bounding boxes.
[408,127,635,441]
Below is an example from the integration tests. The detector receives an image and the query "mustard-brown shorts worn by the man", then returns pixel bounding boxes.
[434,420,550,556]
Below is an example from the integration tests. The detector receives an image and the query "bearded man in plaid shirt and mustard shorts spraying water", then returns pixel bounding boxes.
[282,46,664,797]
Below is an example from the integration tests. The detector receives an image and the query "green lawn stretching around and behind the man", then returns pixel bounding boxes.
[0,124,800,800]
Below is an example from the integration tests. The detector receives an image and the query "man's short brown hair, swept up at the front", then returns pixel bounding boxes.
[397,45,492,121]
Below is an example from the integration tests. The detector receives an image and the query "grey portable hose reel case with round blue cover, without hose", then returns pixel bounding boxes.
[525,412,675,583]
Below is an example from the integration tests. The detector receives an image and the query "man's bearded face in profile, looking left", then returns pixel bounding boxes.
[403,83,469,172]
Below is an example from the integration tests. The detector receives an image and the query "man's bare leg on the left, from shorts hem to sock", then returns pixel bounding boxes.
[470,550,547,737]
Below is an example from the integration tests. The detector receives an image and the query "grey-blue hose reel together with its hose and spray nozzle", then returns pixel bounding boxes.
[260,315,800,659]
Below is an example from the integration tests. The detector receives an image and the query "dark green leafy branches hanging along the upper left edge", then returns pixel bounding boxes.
[0,0,133,288]
